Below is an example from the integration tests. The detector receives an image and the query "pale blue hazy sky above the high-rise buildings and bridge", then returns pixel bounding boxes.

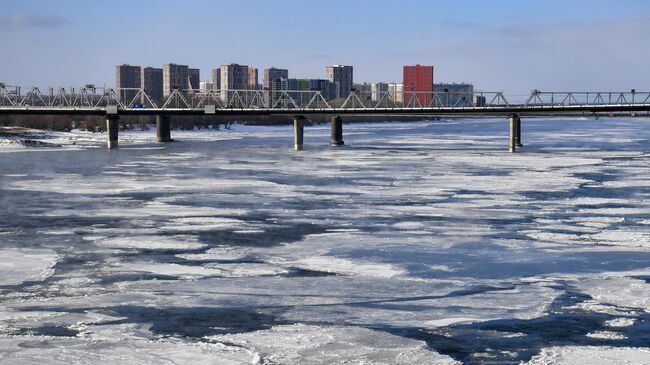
[0,0,650,94]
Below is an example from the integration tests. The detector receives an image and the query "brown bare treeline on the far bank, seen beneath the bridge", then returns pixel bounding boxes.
[0,115,430,132]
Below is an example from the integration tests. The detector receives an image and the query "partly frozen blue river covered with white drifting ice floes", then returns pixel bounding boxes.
[0,119,650,364]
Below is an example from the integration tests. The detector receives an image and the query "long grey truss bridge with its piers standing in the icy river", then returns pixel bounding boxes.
[0,83,650,152]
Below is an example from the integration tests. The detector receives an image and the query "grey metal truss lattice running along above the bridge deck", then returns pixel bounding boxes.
[0,83,650,110]
